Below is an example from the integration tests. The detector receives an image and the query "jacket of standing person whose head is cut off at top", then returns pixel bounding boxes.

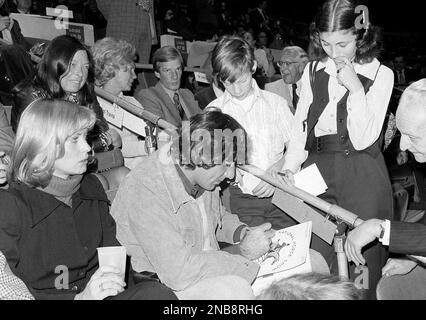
[96,0,152,63]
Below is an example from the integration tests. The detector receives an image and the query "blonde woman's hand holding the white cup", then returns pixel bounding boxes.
[74,267,126,300]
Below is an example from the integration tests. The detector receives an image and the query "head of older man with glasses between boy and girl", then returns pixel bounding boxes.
[278,46,309,84]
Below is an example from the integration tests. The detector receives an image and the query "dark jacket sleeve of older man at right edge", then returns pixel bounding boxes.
[389,221,426,256]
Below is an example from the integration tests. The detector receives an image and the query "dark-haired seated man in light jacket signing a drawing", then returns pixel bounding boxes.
[111,108,274,299]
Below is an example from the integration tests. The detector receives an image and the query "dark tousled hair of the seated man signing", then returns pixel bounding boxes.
[173,107,247,169]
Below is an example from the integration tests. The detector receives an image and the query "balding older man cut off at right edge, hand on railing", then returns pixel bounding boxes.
[345,79,426,298]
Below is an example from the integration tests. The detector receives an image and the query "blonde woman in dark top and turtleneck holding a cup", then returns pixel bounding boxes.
[0,100,176,300]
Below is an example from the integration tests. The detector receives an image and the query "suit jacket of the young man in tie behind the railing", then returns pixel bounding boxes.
[135,82,201,126]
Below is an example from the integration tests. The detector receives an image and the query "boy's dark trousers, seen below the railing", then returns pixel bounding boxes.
[229,186,297,230]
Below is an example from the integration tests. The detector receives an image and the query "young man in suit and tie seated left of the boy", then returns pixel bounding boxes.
[135,46,201,126]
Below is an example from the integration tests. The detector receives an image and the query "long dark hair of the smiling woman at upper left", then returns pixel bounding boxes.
[34,35,96,106]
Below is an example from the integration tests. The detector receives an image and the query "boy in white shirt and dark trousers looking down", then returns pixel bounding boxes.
[209,37,295,230]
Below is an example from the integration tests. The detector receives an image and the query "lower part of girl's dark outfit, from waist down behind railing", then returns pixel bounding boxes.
[304,152,393,299]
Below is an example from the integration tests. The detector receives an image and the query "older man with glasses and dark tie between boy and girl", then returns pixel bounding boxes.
[265,46,309,114]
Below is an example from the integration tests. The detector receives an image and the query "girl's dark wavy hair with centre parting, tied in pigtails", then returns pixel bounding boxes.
[309,0,382,64]
